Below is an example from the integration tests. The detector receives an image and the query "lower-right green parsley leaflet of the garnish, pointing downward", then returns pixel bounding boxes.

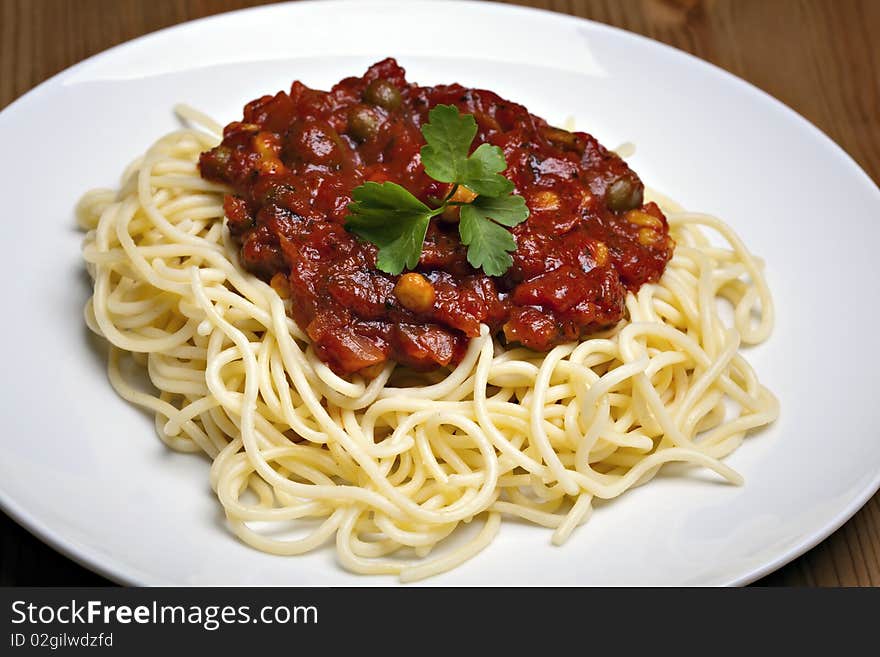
[458,196,529,276]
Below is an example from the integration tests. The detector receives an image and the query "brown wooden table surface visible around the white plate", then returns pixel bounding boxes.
[0,0,880,586]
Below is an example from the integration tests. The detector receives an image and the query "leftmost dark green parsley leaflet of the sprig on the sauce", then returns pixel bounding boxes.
[345,182,437,274]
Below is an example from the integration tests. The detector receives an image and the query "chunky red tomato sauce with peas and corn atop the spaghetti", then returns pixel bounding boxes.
[199,59,674,374]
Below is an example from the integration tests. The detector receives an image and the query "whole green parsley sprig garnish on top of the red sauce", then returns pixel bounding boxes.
[345,105,529,276]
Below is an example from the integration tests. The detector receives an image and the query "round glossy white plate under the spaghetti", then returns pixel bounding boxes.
[0,2,880,585]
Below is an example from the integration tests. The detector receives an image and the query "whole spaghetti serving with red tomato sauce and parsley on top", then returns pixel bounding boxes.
[78,59,778,581]
